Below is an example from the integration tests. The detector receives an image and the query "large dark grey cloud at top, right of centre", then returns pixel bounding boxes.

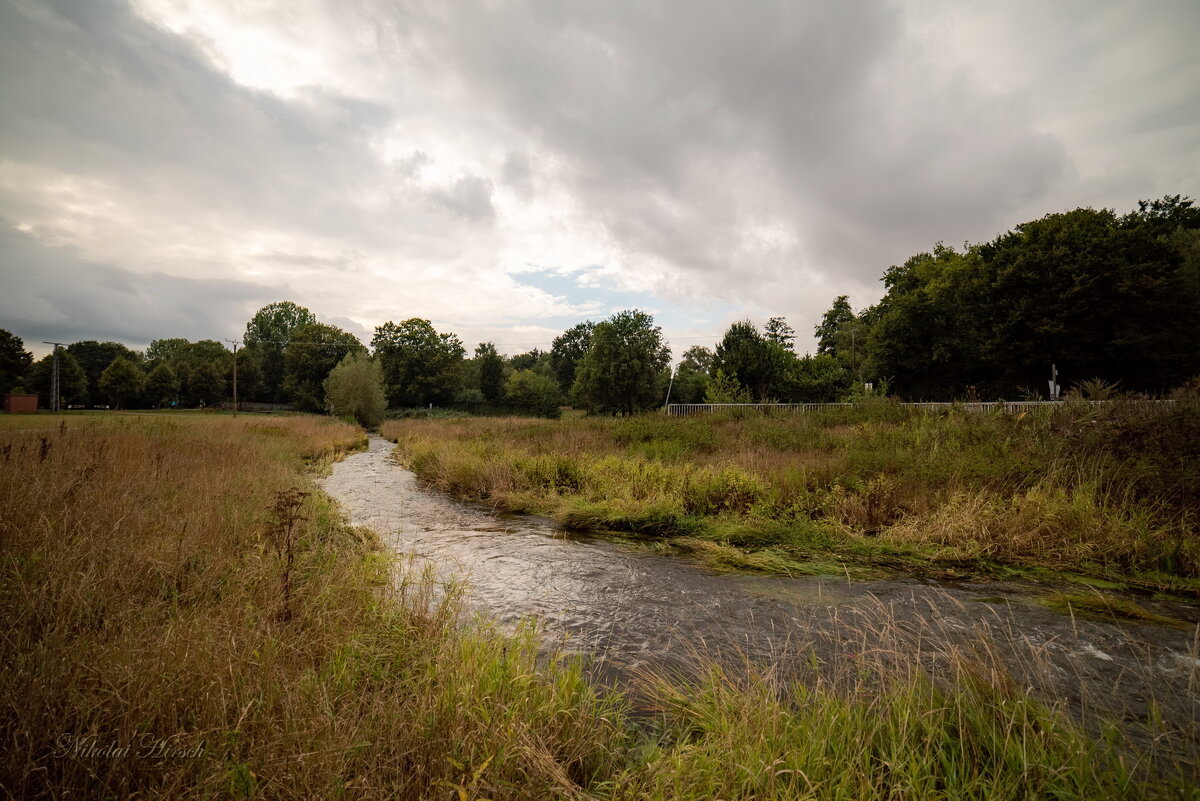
[372,0,1068,284]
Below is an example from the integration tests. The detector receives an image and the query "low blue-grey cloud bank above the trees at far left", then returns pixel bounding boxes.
[0,221,279,347]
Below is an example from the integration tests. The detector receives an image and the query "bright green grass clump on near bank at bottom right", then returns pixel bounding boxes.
[623,670,1195,800]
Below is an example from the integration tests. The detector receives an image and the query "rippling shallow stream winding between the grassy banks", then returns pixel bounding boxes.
[322,436,1200,724]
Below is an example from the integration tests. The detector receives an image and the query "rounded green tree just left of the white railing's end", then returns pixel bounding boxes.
[574,309,671,414]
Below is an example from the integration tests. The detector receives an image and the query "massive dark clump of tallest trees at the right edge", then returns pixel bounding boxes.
[864,197,1200,399]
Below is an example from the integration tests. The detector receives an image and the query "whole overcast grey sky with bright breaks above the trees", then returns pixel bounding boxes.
[0,0,1200,355]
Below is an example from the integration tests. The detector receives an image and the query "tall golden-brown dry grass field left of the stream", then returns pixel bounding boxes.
[0,417,624,799]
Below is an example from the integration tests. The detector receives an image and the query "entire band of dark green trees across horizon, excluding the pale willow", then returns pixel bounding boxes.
[0,195,1200,416]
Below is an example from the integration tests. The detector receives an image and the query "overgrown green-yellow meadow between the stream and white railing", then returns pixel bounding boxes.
[384,393,1200,595]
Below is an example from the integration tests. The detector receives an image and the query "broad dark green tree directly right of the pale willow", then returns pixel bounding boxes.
[371,318,466,406]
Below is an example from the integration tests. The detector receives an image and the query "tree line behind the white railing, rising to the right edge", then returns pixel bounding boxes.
[673,195,1200,403]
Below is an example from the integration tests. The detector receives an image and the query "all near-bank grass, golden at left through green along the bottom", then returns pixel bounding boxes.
[0,415,1196,799]
